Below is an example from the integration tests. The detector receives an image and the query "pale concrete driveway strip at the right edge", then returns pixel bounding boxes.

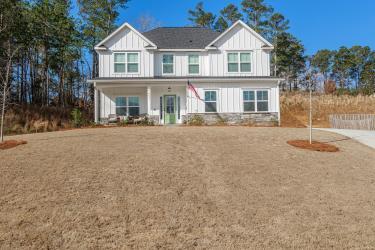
[317,128,375,149]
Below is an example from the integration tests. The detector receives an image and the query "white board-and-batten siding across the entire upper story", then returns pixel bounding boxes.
[97,25,270,78]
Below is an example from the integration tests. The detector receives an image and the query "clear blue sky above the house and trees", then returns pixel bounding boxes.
[86,0,375,54]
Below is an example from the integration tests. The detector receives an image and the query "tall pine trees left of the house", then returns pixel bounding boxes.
[0,0,127,110]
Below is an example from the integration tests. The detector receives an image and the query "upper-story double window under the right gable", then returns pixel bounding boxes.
[227,52,251,73]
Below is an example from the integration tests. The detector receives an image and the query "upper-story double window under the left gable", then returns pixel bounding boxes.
[114,52,139,74]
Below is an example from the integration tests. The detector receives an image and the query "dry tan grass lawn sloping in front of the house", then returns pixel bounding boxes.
[0,127,375,249]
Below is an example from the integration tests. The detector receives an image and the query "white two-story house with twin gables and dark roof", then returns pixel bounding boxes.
[90,21,282,124]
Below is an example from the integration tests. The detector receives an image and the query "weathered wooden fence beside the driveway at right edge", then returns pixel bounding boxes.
[329,114,375,130]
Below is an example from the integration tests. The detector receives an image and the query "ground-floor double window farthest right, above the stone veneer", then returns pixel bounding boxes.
[243,90,269,112]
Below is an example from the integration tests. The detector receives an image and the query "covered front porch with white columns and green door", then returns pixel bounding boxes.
[94,82,187,124]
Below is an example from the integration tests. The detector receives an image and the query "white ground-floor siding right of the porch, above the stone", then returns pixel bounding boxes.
[187,82,279,113]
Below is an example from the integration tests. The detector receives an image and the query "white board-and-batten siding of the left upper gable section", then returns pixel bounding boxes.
[97,28,154,77]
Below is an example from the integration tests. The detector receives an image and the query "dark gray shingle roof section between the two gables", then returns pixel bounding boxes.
[143,27,220,49]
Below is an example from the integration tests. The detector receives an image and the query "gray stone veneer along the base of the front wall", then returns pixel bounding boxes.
[182,112,279,126]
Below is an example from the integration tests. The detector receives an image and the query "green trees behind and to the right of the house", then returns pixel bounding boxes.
[188,0,375,94]
